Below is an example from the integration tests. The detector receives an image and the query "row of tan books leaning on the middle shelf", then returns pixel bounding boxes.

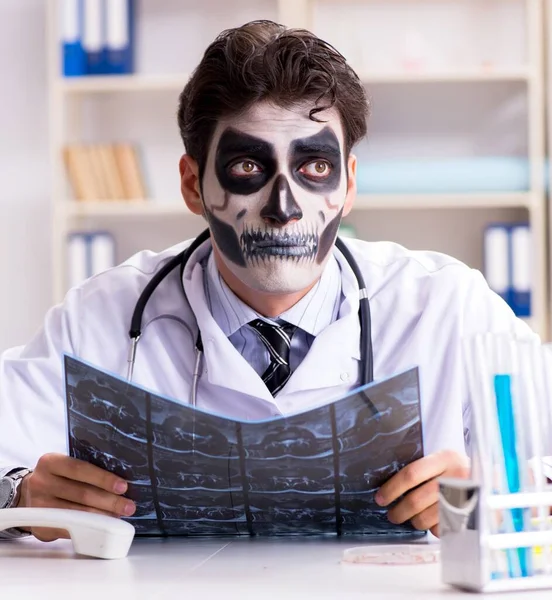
[63,142,148,201]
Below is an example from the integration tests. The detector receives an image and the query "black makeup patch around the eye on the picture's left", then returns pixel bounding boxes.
[215,127,277,196]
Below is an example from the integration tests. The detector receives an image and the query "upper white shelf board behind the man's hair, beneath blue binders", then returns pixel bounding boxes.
[57,67,532,94]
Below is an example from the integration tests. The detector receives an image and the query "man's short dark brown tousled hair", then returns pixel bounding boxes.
[178,21,369,174]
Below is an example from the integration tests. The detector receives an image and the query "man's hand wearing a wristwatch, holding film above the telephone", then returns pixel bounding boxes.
[17,454,136,542]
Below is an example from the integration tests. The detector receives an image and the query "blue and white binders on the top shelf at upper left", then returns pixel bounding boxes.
[60,0,135,77]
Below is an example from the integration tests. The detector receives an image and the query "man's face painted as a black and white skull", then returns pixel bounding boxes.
[202,102,347,294]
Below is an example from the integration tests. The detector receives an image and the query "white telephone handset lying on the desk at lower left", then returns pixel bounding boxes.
[0,508,135,559]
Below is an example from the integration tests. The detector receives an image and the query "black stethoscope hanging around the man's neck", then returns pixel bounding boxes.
[127,229,374,406]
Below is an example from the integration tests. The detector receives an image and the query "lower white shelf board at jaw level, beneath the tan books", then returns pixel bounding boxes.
[60,193,533,218]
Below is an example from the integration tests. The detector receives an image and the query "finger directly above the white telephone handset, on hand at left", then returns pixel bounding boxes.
[50,475,136,517]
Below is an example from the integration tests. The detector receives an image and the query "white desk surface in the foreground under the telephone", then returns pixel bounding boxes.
[0,538,551,600]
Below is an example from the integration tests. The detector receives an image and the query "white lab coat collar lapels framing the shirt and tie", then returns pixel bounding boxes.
[183,241,361,403]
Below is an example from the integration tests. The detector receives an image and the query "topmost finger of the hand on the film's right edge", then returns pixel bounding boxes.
[376,452,450,506]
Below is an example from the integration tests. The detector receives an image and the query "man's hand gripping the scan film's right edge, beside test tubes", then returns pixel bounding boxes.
[376,450,470,536]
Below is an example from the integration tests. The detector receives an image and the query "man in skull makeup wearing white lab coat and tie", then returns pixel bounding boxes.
[0,22,530,540]
